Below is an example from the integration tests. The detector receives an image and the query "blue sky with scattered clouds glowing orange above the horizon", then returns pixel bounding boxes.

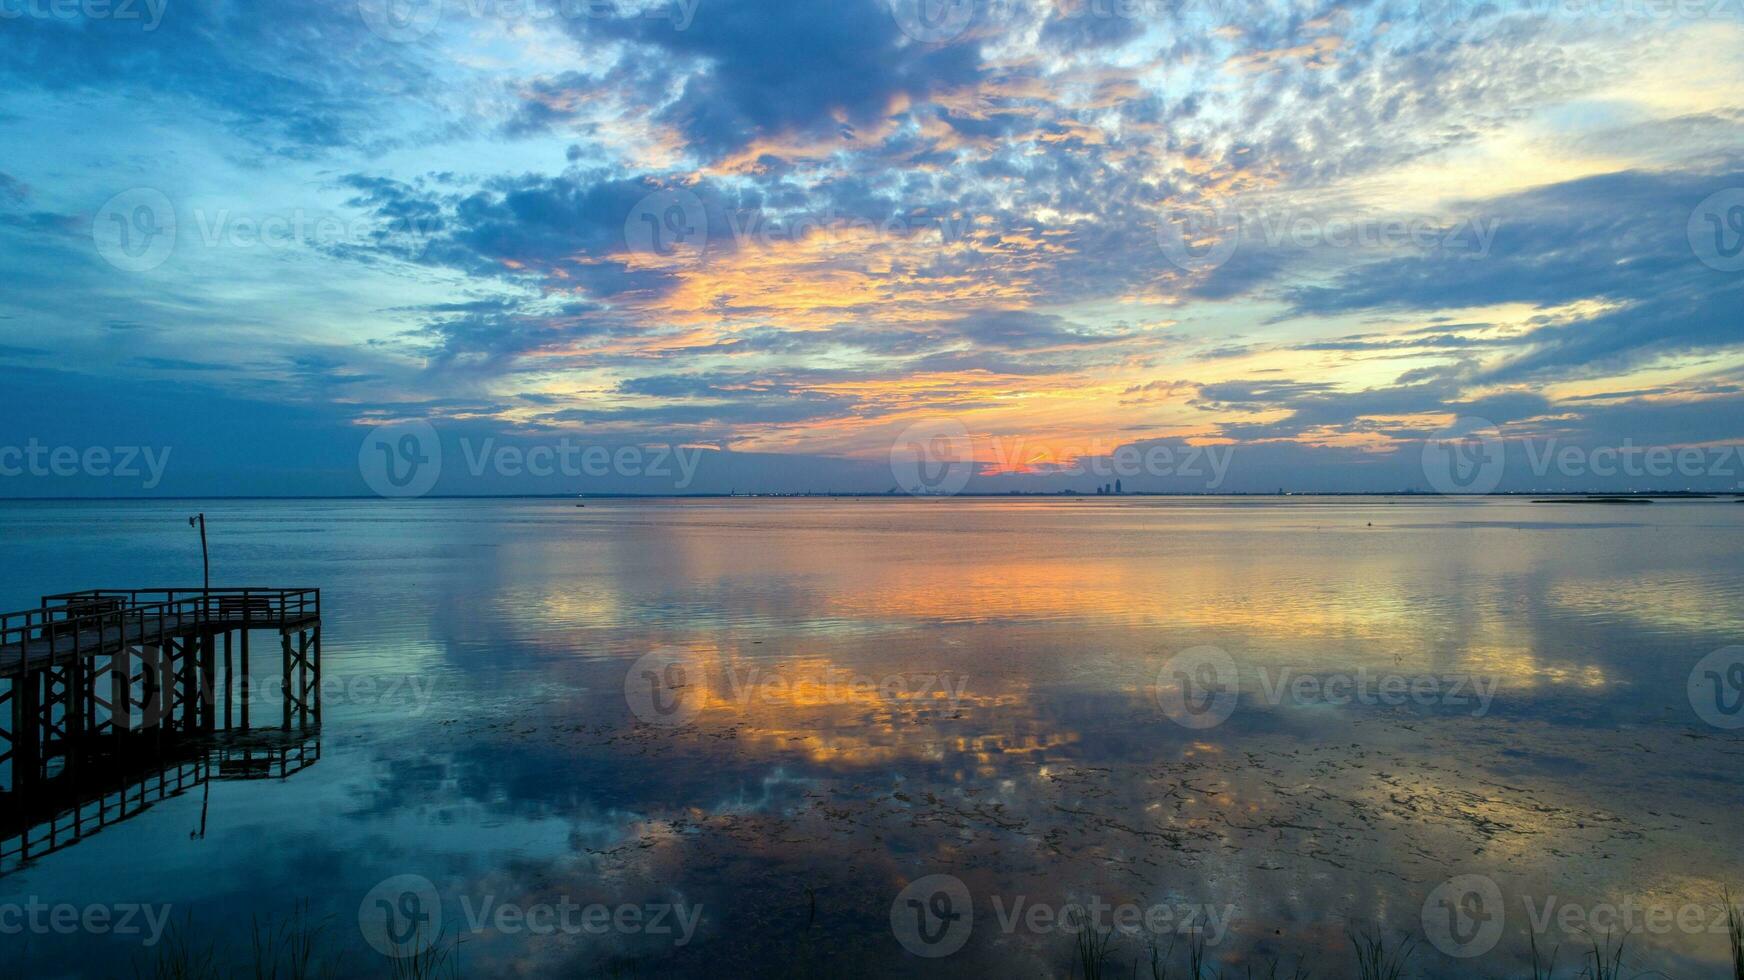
[0,0,1744,497]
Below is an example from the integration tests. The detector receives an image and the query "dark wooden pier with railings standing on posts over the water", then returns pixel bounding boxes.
[0,588,321,795]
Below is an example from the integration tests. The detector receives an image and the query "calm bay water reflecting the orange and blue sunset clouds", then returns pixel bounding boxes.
[0,499,1744,977]
